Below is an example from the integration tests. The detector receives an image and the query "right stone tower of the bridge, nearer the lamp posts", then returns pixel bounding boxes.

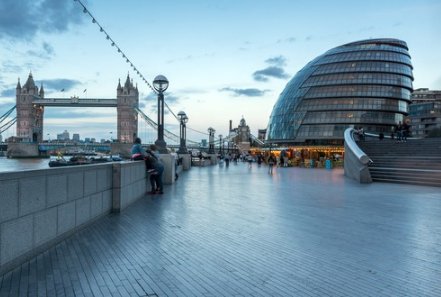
[116,74,139,143]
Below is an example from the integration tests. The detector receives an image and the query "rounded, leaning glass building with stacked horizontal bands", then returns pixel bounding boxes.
[266,39,413,144]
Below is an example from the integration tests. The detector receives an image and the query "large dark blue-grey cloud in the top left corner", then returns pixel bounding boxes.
[0,0,83,40]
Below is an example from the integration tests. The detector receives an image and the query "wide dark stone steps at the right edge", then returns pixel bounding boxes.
[357,138,441,187]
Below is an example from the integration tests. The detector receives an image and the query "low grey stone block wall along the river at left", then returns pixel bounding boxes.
[0,162,146,275]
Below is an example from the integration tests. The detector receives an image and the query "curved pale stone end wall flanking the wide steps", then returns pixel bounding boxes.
[344,128,372,183]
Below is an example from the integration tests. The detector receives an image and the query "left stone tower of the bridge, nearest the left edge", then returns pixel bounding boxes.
[15,73,44,142]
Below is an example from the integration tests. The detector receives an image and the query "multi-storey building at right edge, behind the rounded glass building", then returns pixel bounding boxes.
[409,88,441,137]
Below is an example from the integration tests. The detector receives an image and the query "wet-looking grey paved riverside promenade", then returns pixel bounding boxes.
[0,163,441,296]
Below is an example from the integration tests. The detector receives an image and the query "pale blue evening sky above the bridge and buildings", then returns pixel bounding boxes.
[0,0,441,143]
